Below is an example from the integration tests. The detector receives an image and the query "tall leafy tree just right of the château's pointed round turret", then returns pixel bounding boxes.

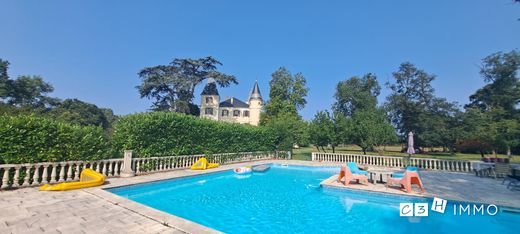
[262,67,309,119]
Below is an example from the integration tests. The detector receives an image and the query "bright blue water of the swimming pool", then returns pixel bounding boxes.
[109,165,520,233]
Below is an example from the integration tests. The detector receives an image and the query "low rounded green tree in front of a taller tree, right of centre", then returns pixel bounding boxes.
[350,109,397,154]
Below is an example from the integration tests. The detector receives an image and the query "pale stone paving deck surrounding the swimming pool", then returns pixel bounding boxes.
[0,160,520,233]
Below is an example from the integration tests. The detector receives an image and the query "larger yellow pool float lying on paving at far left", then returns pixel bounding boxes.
[40,168,105,191]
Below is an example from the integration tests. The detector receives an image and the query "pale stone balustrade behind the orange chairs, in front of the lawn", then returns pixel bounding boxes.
[312,152,473,172]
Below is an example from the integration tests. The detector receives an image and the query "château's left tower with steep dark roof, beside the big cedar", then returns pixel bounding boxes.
[200,78,220,120]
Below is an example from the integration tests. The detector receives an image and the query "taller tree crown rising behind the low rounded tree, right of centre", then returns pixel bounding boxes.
[333,73,381,116]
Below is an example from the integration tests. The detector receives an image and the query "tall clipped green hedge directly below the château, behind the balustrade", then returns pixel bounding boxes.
[112,112,276,156]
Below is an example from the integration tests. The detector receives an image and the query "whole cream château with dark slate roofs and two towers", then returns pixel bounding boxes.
[200,81,263,126]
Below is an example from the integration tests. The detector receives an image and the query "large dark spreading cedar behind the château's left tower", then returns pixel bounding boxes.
[137,56,238,114]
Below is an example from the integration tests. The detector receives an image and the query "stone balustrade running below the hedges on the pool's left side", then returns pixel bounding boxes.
[0,151,284,190]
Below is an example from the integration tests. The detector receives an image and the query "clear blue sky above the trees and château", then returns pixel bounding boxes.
[0,0,520,119]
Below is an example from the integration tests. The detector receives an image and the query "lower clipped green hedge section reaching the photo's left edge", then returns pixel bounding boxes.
[0,115,112,163]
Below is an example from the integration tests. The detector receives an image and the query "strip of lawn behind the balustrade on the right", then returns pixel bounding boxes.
[293,145,520,163]
